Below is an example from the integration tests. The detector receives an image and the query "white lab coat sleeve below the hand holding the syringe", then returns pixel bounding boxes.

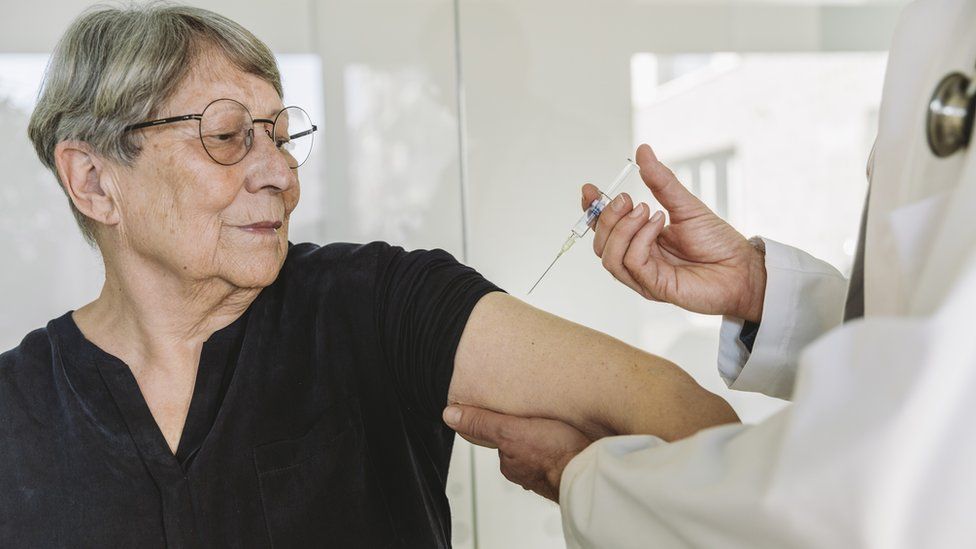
[718,237,847,400]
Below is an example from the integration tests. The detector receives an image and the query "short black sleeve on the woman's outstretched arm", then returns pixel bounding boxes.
[374,246,501,421]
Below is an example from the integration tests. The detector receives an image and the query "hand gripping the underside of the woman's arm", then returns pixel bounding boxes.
[443,404,591,503]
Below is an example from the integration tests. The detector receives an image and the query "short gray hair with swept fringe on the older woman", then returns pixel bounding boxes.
[27,2,282,245]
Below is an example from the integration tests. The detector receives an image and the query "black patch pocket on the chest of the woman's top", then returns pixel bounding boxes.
[254,414,395,548]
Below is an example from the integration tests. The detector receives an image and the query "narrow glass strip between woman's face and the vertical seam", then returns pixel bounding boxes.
[310,4,475,549]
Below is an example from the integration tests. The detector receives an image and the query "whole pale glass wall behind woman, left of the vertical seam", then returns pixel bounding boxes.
[0,0,475,549]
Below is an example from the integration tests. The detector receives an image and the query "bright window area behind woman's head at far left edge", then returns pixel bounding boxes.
[0,54,103,351]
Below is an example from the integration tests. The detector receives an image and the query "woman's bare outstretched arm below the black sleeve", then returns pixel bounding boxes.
[448,293,738,441]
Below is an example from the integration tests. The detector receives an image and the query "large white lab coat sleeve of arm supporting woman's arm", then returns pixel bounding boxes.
[560,250,976,549]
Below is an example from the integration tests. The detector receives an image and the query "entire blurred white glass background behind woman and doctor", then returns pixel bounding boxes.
[0,0,904,549]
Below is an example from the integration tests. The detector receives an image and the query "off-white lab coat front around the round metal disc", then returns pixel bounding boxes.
[865,0,976,315]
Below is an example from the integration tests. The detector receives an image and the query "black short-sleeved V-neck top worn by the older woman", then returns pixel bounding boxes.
[0,243,498,549]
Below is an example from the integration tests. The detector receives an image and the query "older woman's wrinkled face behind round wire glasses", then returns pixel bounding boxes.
[117,54,299,288]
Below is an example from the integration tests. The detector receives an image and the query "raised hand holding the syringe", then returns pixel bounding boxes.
[583,145,766,322]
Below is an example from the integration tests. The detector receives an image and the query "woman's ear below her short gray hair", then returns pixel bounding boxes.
[54,141,121,225]
